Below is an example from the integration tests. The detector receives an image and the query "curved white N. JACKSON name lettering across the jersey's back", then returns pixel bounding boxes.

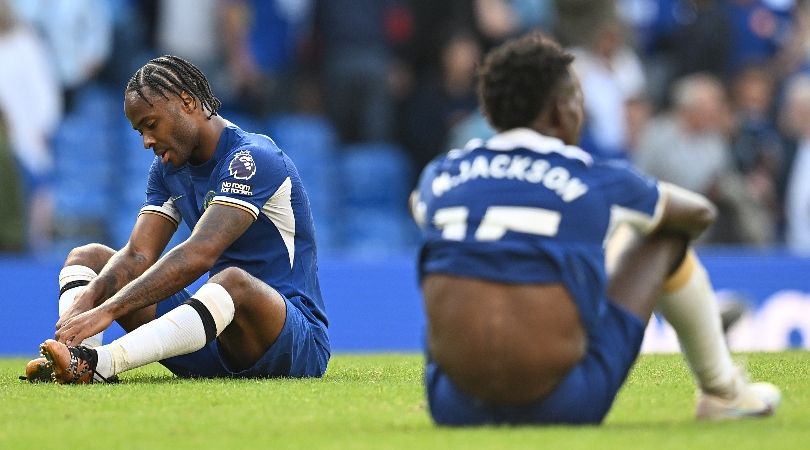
[431,154,588,203]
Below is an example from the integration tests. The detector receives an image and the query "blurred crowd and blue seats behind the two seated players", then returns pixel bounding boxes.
[0,0,810,253]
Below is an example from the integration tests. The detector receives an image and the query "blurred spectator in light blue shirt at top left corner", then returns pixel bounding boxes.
[15,0,113,110]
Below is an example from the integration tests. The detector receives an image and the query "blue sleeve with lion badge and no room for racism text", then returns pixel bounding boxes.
[211,147,292,220]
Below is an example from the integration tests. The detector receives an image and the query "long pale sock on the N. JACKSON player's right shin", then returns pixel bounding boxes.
[658,250,735,396]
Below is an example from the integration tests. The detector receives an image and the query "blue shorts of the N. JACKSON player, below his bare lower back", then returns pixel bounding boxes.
[425,301,645,426]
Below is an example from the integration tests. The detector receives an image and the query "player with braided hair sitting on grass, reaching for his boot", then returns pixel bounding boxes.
[27,56,330,383]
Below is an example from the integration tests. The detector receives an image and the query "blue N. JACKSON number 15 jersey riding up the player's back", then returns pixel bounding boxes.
[411,128,663,328]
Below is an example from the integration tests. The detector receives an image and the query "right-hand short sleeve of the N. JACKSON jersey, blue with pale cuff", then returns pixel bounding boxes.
[599,161,664,234]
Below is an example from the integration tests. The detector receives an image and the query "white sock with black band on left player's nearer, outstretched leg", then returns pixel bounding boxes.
[96,283,235,378]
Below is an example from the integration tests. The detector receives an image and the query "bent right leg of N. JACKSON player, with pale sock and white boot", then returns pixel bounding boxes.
[607,229,781,419]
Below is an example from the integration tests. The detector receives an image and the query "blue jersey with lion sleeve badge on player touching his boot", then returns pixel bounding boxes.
[141,123,327,325]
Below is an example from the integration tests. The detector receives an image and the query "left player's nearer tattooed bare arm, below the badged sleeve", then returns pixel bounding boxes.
[56,204,254,345]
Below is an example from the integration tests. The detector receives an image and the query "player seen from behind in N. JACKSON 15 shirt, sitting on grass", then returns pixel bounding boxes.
[411,34,780,425]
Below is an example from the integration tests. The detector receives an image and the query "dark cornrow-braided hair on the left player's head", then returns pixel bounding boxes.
[126,55,222,119]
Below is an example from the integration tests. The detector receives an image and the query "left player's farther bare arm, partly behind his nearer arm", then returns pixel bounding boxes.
[56,214,177,329]
